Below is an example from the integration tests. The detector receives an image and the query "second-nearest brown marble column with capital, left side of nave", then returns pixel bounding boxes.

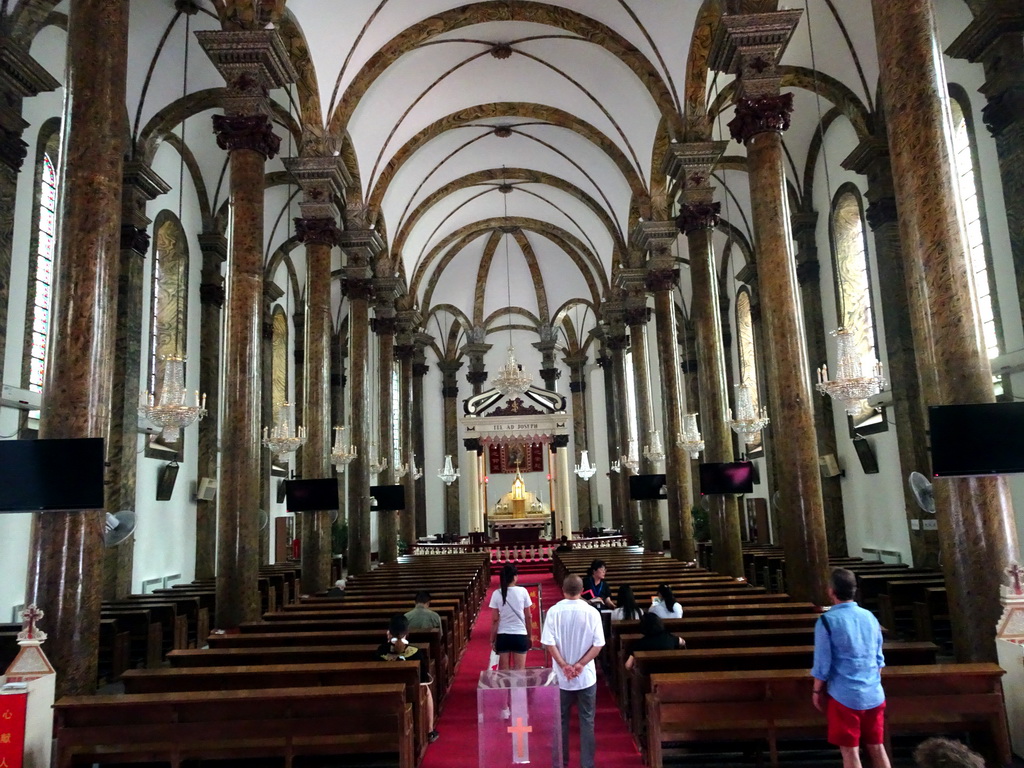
[196,30,296,629]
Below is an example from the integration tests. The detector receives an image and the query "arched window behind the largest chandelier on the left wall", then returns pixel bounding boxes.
[146,211,188,458]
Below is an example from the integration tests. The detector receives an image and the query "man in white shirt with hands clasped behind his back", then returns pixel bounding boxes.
[541,574,604,768]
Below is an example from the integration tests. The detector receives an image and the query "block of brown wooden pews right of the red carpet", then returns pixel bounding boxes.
[555,548,1011,768]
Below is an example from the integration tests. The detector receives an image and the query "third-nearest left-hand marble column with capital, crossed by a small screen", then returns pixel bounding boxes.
[285,156,351,593]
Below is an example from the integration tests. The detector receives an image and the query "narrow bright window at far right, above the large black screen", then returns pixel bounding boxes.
[949,85,1002,366]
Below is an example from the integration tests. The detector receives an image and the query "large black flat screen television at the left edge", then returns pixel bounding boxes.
[0,437,106,512]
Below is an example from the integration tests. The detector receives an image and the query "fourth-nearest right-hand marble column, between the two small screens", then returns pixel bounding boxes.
[633,221,700,572]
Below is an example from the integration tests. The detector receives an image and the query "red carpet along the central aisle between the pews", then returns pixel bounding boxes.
[421,573,643,768]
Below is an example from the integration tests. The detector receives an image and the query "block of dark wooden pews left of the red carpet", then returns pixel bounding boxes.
[54,554,489,768]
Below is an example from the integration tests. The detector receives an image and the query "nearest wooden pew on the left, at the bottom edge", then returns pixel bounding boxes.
[53,685,415,768]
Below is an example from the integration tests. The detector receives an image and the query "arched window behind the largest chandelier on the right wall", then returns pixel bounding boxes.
[830,184,885,431]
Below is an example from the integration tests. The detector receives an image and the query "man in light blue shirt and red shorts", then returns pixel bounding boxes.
[811,568,890,768]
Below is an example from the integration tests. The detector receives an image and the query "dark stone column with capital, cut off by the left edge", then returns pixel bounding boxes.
[0,35,60,370]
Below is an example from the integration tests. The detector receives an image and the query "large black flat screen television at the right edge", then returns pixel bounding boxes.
[928,402,1024,477]
